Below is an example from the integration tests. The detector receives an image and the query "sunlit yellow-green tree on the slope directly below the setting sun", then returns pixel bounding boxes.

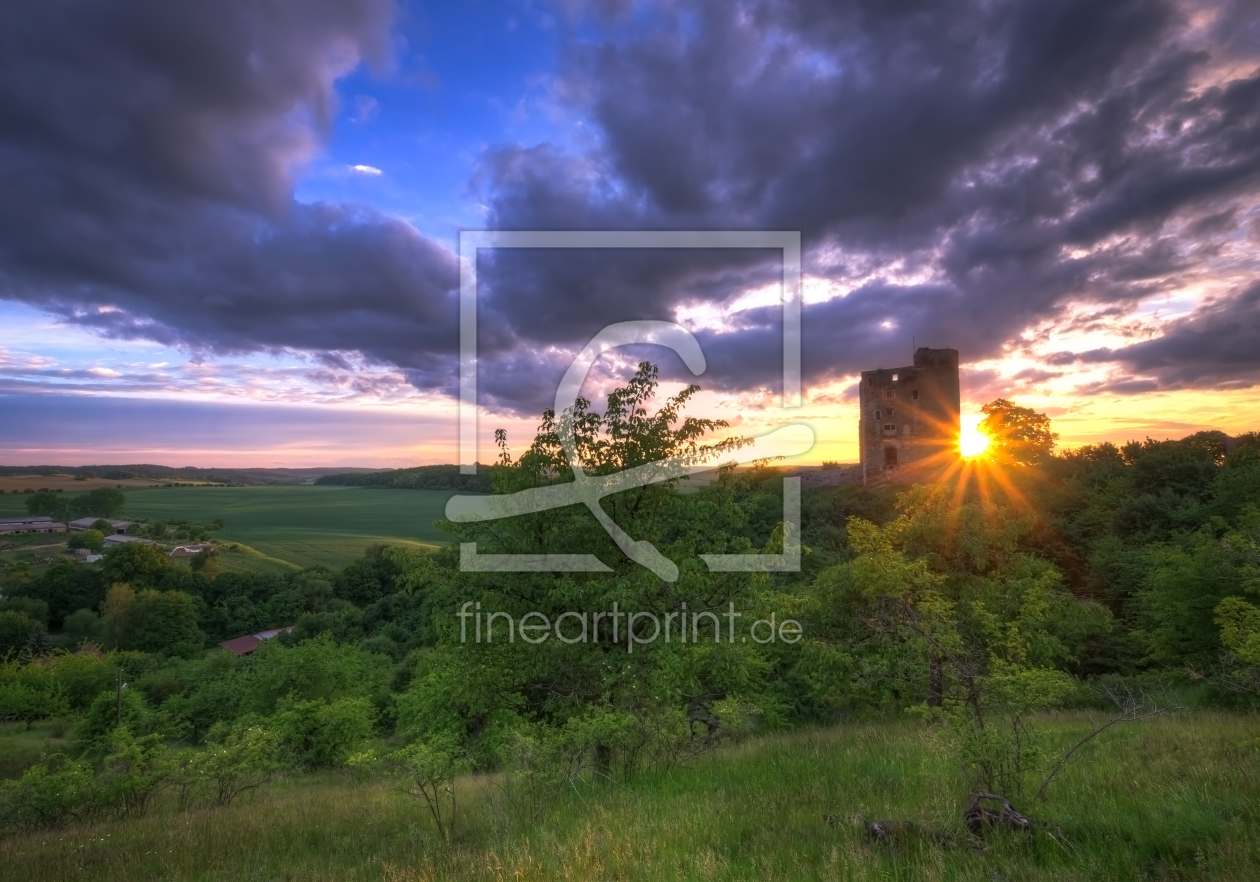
[819,486,1110,794]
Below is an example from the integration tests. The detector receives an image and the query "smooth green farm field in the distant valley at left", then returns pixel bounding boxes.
[0,485,471,571]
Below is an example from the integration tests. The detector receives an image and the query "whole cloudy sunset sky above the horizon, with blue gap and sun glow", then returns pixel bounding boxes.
[0,0,1260,466]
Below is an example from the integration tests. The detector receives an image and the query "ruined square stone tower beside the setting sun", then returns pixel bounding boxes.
[858,347,963,483]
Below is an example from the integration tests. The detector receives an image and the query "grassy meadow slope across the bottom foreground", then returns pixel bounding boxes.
[0,712,1260,882]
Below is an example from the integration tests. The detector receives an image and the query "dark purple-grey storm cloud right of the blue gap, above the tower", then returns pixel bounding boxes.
[479,0,1260,405]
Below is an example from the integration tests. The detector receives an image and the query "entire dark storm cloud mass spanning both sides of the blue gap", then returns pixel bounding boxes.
[0,0,1260,413]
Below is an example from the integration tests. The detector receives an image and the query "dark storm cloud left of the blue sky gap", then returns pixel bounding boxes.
[0,0,468,384]
